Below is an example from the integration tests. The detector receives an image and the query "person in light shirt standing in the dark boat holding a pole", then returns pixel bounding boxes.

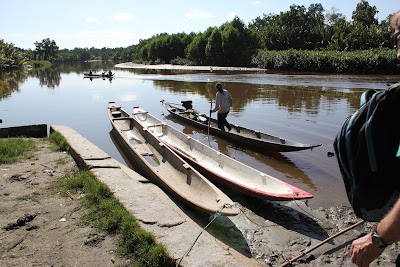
[210,83,233,131]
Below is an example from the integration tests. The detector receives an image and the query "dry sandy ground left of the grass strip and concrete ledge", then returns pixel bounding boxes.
[0,139,130,267]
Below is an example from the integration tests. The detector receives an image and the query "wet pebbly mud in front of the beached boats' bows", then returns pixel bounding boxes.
[236,201,400,266]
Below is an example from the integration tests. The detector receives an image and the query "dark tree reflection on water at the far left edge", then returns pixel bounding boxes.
[0,70,28,99]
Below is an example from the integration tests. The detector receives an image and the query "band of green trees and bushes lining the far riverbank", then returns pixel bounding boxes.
[0,0,400,74]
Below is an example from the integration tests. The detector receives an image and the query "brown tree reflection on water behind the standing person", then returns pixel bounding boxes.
[153,80,362,114]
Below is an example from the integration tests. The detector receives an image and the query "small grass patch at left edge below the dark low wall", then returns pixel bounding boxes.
[0,138,37,164]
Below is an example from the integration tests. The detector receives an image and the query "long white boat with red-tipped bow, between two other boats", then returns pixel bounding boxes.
[133,104,313,200]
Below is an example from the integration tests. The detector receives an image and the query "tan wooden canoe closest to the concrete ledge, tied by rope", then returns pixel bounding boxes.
[108,102,239,216]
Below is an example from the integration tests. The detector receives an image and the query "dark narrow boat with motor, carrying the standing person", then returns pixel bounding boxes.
[161,100,322,152]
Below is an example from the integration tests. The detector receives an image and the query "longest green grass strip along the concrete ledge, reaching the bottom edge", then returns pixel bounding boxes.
[62,171,175,267]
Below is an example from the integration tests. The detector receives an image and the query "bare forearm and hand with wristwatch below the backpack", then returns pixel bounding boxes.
[350,199,400,267]
